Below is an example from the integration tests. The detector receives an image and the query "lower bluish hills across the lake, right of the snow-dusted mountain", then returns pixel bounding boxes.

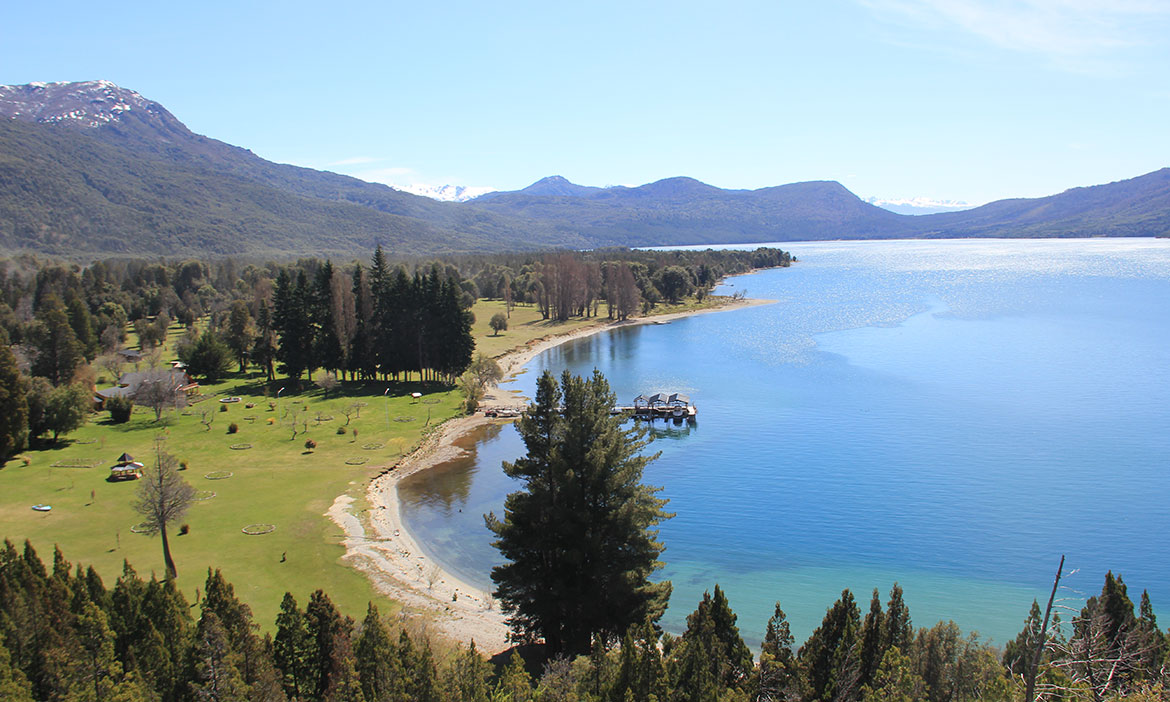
[469,168,1170,246]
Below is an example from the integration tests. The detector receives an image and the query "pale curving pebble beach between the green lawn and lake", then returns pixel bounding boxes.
[326,294,775,655]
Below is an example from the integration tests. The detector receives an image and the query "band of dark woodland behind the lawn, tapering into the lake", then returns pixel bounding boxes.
[0,247,792,459]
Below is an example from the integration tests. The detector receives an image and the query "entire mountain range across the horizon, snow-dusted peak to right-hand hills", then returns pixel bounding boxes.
[0,81,1170,257]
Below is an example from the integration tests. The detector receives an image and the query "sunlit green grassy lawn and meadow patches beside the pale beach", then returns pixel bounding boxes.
[0,293,723,629]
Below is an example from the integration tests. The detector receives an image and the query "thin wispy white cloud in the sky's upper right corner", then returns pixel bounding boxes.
[858,0,1170,67]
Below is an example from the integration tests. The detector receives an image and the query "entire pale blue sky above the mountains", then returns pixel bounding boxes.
[0,0,1170,204]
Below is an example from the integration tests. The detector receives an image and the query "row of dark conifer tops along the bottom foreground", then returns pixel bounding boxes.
[0,541,1166,702]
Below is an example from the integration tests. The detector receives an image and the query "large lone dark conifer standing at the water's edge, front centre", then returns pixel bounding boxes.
[487,371,670,653]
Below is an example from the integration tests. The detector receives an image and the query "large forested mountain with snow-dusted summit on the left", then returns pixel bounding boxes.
[0,81,587,257]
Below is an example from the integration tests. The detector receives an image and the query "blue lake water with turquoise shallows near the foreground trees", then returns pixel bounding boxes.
[400,240,1170,642]
